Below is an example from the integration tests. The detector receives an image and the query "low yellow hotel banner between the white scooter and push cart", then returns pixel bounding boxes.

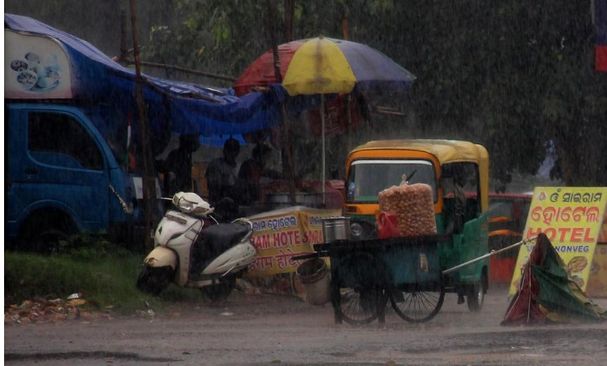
[248,206,341,277]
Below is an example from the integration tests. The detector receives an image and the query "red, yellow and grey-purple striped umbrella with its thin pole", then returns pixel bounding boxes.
[234,37,415,201]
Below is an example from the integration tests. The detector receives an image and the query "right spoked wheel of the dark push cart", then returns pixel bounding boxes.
[390,286,445,323]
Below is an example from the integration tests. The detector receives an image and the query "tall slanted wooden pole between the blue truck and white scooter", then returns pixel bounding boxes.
[129,0,156,248]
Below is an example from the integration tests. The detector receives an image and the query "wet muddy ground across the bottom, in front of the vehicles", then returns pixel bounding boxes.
[4,288,607,366]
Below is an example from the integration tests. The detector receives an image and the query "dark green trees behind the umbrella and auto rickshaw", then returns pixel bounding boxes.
[138,0,607,185]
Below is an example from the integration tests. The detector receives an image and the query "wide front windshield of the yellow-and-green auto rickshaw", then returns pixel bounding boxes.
[346,160,437,203]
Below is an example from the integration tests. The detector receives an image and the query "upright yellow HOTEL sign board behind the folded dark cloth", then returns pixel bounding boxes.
[509,187,607,295]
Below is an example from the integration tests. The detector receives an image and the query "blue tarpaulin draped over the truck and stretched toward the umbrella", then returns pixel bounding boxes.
[4,14,285,143]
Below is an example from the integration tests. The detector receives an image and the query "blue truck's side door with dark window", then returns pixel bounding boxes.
[9,108,109,231]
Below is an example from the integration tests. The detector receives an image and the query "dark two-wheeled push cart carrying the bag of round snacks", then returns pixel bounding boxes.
[296,235,448,324]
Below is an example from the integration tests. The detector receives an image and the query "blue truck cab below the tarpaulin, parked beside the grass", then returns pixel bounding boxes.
[5,101,142,249]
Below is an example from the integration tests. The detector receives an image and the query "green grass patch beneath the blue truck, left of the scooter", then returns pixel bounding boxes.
[4,238,202,314]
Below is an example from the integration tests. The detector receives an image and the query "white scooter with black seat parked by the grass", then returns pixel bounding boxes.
[137,192,256,301]
